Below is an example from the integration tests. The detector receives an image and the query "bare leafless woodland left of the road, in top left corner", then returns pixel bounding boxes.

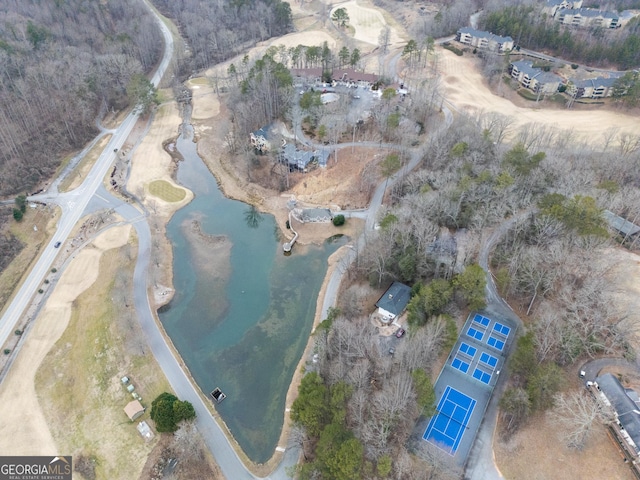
[0,0,163,195]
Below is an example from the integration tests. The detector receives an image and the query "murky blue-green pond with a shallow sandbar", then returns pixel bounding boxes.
[160,125,346,463]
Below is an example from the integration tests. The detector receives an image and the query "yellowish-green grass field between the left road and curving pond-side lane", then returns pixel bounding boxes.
[36,241,171,479]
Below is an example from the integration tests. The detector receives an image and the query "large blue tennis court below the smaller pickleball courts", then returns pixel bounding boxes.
[422,385,476,455]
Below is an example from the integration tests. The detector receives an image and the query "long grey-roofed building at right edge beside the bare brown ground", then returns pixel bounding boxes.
[593,373,640,456]
